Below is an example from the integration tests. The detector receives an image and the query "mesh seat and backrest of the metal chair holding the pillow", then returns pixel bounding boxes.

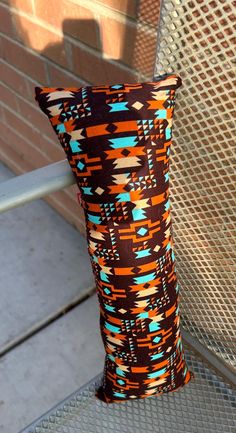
[14,0,236,433]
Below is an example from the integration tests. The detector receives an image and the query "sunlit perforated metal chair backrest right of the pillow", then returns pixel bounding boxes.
[154,0,236,368]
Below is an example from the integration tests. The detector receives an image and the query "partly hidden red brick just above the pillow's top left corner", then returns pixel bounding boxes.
[48,64,87,87]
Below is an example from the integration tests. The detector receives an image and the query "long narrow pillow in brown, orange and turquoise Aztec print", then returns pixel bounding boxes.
[35,74,194,403]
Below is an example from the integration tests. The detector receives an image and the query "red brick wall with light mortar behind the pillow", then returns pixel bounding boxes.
[0,0,159,232]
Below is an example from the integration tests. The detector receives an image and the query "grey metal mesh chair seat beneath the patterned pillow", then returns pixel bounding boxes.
[20,346,236,433]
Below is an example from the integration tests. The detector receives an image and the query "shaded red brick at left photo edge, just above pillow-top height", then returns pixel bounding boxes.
[0,37,47,85]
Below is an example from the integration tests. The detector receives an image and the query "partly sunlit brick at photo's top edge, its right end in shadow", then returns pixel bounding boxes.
[35,0,99,48]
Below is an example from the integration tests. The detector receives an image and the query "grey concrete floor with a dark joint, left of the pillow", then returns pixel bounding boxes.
[0,164,105,433]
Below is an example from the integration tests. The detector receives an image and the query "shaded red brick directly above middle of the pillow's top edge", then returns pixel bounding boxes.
[72,45,136,85]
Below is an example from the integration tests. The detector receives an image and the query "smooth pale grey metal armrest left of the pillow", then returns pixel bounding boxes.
[0,159,76,213]
